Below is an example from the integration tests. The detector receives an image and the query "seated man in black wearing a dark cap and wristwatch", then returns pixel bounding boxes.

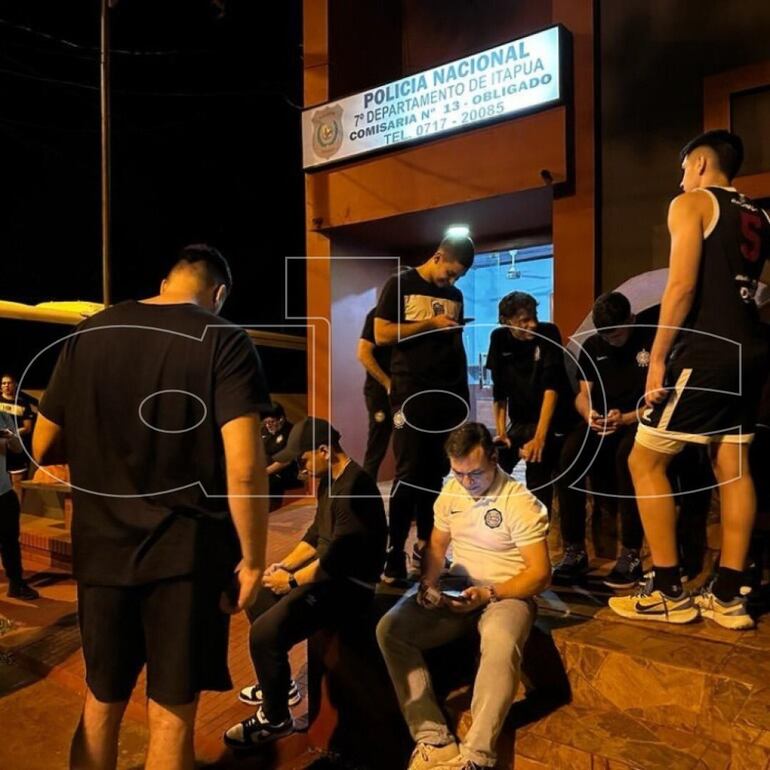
[224,417,387,748]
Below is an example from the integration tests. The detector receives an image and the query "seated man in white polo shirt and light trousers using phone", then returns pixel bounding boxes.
[377,423,551,770]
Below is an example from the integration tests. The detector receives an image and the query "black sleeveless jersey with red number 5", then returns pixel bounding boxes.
[671,187,770,366]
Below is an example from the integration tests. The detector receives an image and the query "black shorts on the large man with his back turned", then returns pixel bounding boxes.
[78,577,232,706]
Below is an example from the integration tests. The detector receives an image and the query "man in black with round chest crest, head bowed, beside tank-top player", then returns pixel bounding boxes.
[553,291,654,588]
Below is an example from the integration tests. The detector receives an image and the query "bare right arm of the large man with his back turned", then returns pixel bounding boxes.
[222,414,268,609]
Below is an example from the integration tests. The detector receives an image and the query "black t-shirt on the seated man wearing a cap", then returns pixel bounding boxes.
[302,461,388,585]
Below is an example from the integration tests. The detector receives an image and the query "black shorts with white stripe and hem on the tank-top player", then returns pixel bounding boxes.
[636,361,767,454]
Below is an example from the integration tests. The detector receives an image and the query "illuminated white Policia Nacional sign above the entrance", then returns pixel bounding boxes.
[302,27,563,169]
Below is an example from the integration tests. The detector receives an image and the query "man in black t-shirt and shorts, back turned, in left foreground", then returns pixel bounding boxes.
[33,245,270,770]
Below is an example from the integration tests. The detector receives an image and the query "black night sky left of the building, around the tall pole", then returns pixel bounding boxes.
[0,0,304,385]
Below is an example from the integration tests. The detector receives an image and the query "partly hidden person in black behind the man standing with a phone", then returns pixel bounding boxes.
[356,308,393,481]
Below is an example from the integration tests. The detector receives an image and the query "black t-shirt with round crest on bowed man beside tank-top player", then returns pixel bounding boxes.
[577,326,655,414]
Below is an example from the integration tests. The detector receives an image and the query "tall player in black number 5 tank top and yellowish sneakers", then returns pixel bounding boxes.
[610,130,770,629]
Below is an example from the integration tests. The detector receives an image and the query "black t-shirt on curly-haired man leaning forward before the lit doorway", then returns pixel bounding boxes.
[486,323,574,430]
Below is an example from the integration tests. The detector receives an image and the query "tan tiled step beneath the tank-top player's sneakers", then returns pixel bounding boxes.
[538,591,770,746]
